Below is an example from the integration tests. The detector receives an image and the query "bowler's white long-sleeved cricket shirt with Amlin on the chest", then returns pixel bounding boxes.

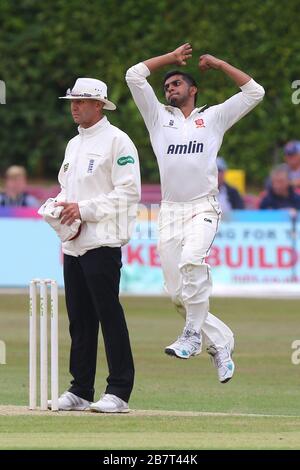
[126,62,265,202]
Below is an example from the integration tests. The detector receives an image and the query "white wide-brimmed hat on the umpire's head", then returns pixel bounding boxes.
[59,78,116,111]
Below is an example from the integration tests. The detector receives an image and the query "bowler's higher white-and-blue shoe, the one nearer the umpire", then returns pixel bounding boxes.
[165,326,202,359]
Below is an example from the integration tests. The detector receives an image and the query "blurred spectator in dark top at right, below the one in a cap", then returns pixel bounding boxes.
[259,165,300,210]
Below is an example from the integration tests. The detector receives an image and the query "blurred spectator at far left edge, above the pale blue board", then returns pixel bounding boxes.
[0,165,40,207]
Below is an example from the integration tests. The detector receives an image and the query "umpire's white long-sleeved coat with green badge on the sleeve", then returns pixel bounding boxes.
[57,117,141,256]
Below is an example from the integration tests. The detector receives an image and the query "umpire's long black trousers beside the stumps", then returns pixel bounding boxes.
[64,247,134,402]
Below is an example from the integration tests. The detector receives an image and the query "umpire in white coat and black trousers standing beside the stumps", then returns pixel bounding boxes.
[49,78,140,413]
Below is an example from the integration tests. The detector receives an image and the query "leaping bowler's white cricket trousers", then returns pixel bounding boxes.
[158,196,233,347]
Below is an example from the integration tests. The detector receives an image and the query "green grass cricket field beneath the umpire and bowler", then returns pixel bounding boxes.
[0,294,300,450]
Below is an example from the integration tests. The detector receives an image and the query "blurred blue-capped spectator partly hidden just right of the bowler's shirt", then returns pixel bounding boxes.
[217,157,245,213]
